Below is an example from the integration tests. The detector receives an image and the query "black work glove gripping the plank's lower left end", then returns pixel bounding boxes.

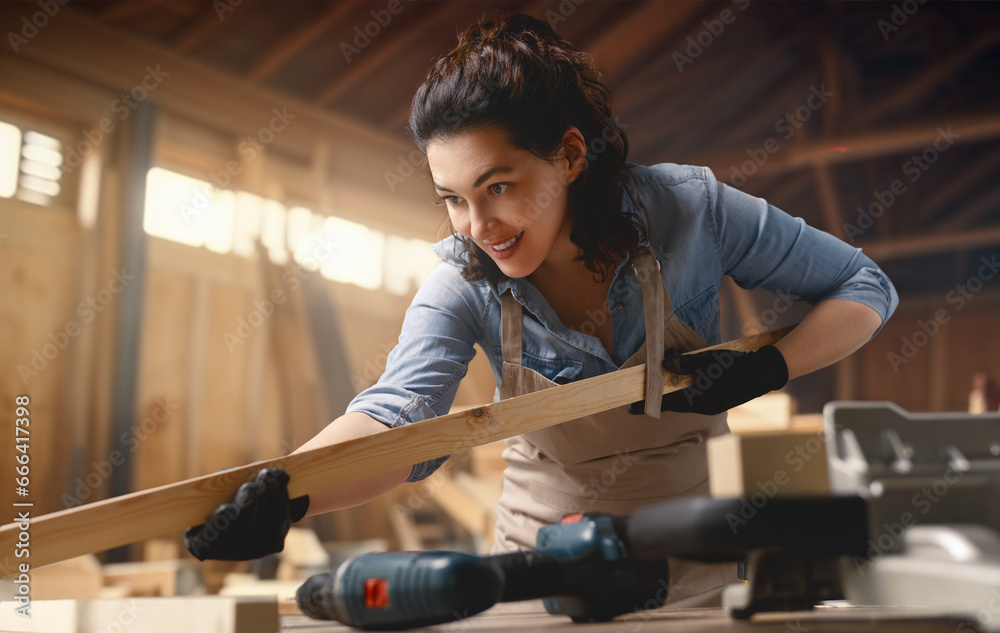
[184,468,309,560]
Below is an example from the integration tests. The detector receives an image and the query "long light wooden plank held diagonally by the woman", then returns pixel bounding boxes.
[0,327,792,567]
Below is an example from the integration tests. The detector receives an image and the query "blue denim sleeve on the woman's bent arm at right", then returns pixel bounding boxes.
[706,170,899,336]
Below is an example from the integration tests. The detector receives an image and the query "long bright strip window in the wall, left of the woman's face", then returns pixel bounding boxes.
[143,167,439,295]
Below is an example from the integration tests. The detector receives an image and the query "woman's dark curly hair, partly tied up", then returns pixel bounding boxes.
[409,15,648,283]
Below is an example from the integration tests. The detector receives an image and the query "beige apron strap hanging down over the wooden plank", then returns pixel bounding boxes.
[632,248,673,419]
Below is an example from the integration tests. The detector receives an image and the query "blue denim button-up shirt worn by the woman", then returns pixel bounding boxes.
[347,164,899,481]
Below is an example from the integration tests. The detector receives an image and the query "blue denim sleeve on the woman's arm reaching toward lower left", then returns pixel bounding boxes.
[347,263,482,481]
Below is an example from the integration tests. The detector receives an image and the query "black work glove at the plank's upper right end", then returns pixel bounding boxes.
[628,345,788,415]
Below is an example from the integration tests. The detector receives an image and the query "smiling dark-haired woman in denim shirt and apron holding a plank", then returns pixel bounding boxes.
[187,16,897,606]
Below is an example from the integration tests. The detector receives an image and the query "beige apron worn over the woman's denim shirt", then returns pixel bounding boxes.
[493,249,739,607]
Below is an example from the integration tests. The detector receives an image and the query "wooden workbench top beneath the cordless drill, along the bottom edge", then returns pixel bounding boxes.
[281,601,980,633]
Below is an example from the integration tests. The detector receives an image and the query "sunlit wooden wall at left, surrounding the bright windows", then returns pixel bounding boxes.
[0,18,493,552]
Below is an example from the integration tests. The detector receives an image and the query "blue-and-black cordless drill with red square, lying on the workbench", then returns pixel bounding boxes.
[296,514,668,630]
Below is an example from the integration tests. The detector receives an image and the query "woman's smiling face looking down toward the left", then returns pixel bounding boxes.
[427,127,583,278]
